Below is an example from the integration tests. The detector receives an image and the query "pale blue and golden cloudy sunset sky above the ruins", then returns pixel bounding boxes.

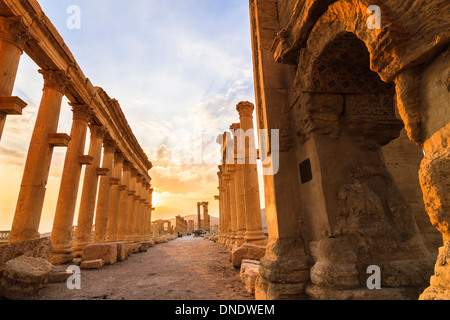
[0,0,264,232]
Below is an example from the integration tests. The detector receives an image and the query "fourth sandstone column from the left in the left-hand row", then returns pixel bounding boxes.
[72,125,105,256]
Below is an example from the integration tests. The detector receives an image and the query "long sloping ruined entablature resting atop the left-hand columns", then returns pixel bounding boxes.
[0,0,153,179]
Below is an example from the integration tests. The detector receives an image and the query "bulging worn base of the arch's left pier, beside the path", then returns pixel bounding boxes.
[255,239,312,300]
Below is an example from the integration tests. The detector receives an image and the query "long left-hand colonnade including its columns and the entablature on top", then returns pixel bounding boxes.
[0,0,153,264]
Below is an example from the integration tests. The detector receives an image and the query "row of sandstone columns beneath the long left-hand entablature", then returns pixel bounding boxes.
[0,17,153,263]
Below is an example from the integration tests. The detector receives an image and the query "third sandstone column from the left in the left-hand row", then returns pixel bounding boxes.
[50,105,92,264]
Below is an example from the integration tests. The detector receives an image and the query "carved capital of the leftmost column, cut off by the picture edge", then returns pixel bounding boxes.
[0,17,32,51]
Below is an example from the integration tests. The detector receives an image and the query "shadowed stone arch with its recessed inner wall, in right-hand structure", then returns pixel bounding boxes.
[294,10,433,299]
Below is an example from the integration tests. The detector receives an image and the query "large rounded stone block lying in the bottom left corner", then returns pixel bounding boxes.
[0,256,54,300]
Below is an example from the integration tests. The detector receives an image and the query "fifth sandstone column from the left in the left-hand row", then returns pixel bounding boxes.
[93,138,116,243]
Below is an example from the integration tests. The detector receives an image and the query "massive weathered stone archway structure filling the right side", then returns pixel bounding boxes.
[251,0,450,299]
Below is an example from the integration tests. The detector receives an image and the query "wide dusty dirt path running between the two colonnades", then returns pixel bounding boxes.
[32,237,253,300]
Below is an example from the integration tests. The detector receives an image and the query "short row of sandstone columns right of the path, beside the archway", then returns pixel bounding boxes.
[216,102,266,247]
